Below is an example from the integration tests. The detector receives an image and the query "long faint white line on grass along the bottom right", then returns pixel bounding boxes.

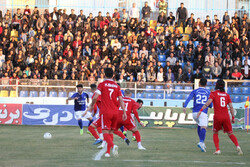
[123,160,246,165]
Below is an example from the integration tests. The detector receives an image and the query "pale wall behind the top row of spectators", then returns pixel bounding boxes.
[0,0,250,21]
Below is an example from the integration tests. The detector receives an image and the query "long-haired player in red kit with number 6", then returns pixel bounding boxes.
[197,79,243,155]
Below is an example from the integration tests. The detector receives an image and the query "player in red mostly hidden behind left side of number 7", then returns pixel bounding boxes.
[88,84,103,145]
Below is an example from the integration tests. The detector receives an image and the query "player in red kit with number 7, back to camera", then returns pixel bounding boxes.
[88,68,127,157]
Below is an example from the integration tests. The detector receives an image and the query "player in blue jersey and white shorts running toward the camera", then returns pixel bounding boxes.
[66,84,93,135]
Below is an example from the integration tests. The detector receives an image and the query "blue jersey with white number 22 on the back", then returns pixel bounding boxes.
[184,87,212,113]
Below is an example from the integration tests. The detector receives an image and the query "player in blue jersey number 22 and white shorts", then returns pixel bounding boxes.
[183,78,212,152]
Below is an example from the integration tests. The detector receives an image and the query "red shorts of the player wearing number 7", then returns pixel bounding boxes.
[100,113,118,130]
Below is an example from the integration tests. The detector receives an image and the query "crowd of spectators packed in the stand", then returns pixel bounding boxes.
[0,0,250,83]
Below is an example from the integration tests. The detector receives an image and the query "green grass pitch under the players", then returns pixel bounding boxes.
[0,125,250,167]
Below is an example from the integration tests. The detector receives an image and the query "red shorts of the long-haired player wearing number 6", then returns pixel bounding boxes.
[213,117,233,133]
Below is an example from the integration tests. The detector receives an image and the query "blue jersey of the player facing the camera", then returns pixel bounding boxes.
[71,92,89,111]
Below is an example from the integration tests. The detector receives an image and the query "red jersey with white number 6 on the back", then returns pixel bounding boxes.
[209,90,232,117]
